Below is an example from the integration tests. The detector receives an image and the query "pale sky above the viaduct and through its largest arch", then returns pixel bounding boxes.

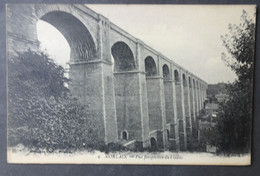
[37,5,255,84]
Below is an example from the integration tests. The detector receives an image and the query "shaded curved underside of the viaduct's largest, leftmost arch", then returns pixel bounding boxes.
[40,11,97,62]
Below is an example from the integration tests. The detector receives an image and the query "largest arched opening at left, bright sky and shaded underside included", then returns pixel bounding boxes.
[36,11,96,86]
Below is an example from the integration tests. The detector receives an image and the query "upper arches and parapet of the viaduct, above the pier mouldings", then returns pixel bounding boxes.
[7,4,207,89]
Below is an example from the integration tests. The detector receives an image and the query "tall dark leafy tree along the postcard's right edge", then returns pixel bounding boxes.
[210,11,255,154]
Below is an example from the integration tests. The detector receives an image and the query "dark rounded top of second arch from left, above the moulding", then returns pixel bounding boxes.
[111,42,135,72]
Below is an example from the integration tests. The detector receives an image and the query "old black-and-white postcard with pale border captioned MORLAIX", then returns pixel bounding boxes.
[6,4,256,165]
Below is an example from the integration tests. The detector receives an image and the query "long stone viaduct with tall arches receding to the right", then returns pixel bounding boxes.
[6,4,207,150]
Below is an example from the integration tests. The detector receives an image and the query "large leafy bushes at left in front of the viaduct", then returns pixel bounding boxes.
[8,51,119,152]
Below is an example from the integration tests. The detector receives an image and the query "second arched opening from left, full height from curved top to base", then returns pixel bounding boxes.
[111,41,138,139]
